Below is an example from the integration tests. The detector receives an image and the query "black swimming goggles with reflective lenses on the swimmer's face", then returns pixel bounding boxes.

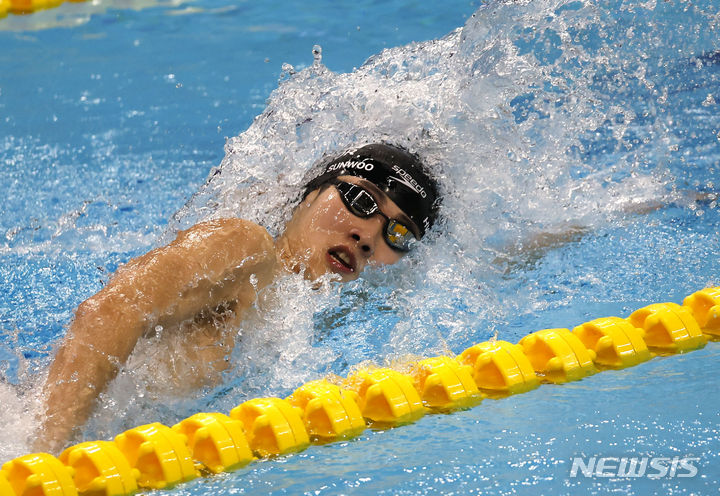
[330,180,415,252]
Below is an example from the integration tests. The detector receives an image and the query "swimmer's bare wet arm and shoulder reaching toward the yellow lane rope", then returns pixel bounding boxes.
[36,219,276,449]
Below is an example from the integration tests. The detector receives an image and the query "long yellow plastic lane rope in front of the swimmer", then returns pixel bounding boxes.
[0,286,720,496]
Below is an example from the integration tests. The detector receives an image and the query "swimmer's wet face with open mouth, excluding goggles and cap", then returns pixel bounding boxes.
[283,176,417,281]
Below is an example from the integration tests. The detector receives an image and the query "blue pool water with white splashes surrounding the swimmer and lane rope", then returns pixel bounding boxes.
[0,1,720,495]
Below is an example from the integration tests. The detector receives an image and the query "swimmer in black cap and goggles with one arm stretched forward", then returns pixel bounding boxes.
[36,144,438,450]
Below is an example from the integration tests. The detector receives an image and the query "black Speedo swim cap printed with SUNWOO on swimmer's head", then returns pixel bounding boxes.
[305,143,438,237]
